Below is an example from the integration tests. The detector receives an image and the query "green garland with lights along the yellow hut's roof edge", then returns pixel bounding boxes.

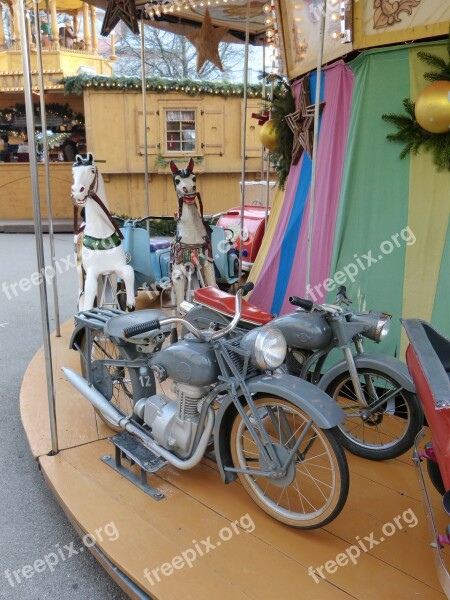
[58,75,261,98]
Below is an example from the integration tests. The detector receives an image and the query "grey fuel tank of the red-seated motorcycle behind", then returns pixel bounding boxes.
[271,310,333,350]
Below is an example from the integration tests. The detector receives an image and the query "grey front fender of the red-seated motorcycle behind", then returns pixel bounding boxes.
[318,354,416,394]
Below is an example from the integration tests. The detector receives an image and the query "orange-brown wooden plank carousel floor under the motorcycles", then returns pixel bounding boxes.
[20,304,447,600]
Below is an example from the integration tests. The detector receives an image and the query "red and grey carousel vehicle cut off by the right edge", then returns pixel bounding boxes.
[401,319,450,598]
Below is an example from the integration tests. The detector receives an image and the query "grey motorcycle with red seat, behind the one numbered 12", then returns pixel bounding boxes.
[185,286,423,460]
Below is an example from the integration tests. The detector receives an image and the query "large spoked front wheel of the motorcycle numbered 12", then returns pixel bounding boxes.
[230,397,349,529]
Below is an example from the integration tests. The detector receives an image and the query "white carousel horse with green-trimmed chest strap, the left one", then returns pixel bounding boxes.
[71,153,135,310]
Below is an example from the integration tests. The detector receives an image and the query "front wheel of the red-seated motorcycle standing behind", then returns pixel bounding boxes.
[326,369,423,460]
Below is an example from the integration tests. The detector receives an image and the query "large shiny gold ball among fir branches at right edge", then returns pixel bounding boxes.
[415,81,450,133]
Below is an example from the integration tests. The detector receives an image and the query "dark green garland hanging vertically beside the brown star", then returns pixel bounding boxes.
[270,79,295,190]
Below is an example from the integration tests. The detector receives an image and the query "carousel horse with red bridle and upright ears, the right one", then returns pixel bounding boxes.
[170,158,217,310]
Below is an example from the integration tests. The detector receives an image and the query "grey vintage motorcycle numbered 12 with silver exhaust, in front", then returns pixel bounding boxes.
[64,284,349,529]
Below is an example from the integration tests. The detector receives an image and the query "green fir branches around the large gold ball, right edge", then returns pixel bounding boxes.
[382,35,450,171]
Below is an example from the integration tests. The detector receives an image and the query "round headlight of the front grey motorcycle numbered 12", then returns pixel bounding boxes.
[241,327,287,371]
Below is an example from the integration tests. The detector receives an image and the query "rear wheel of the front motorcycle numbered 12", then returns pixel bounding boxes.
[80,332,141,431]
